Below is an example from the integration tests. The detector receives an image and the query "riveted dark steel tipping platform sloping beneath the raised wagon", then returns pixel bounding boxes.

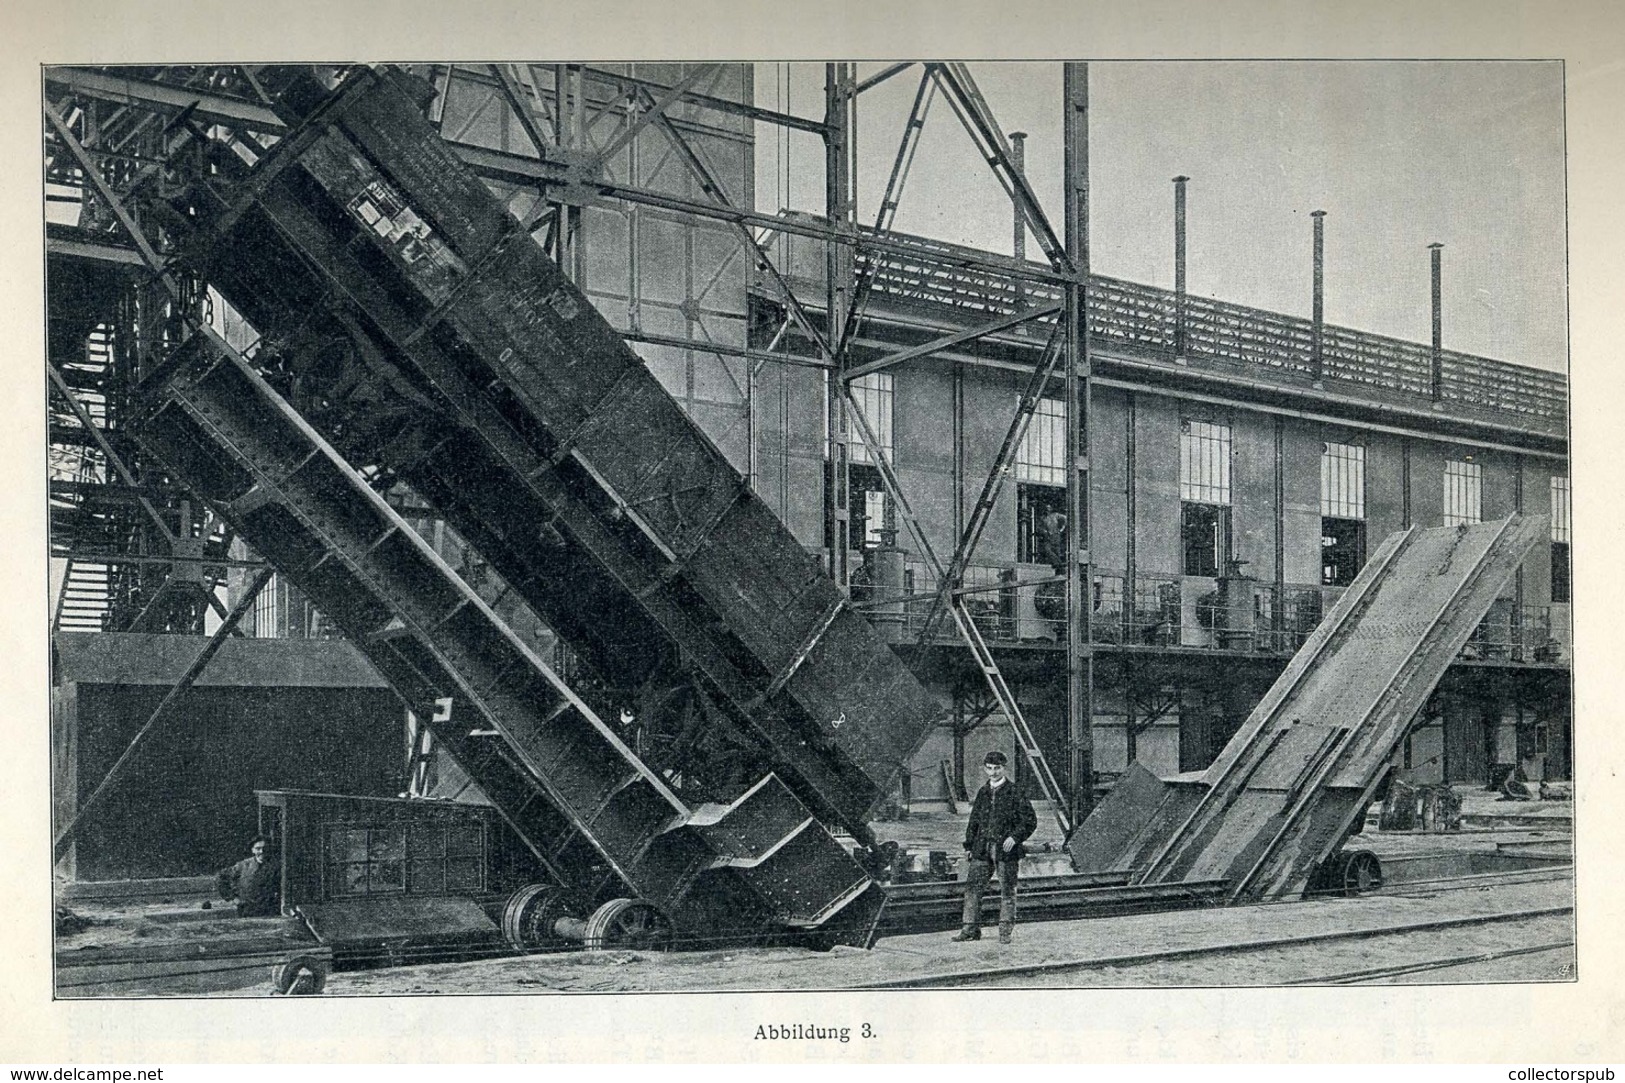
[132,332,882,943]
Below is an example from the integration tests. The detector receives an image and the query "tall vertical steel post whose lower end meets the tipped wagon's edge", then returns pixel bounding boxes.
[824,63,856,592]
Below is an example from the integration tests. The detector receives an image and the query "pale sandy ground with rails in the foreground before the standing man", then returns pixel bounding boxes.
[316,880,1573,995]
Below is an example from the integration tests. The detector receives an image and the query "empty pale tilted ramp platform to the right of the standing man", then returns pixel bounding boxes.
[1069,515,1547,901]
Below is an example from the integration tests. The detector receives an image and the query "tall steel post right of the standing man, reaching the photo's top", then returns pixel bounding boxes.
[1063,62,1095,824]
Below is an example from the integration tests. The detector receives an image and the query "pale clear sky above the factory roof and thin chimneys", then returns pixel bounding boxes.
[756,60,1568,371]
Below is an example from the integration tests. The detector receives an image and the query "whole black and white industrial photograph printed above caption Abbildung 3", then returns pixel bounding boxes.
[15,0,1612,1052]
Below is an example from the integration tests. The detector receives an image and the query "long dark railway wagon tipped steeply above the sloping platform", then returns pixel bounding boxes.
[169,68,934,839]
